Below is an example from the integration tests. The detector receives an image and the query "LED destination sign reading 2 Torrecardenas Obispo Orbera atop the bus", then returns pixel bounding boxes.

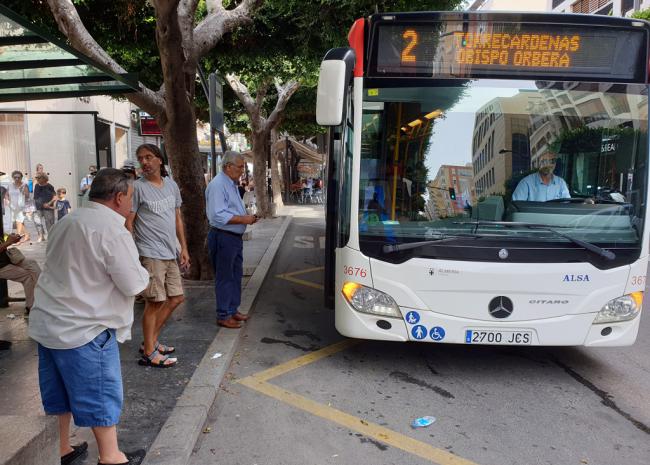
[368,21,647,82]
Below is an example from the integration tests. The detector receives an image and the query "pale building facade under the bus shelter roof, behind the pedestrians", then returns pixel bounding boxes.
[0,97,132,207]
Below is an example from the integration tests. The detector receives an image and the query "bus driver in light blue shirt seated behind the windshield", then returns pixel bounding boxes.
[512,152,571,202]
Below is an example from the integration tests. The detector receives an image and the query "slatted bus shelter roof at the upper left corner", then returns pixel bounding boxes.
[0,5,139,102]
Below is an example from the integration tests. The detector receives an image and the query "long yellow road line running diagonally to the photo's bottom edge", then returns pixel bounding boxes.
[239,376,477,465]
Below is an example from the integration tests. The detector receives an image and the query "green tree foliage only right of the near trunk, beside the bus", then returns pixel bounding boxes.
[203,0,463,136]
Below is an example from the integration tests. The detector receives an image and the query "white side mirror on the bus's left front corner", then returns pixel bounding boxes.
[316,48,355,126]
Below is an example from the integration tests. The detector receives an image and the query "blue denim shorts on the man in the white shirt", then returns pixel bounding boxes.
[38,329,124,427]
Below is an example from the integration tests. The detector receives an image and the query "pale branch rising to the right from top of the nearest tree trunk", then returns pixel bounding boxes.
[194,0,263,60]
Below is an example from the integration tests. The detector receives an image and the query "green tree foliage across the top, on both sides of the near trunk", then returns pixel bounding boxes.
[3,0,463,136]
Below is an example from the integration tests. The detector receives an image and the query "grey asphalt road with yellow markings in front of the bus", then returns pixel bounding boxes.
[192,208,650,465]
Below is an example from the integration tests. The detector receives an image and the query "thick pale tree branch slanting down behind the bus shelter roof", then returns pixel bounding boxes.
[47,0,165,115]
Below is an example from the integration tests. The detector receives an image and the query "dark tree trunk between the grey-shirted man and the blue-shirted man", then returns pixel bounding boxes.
[162,112,212,279]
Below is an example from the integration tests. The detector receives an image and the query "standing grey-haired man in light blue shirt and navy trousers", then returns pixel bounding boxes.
[205,151,257,328]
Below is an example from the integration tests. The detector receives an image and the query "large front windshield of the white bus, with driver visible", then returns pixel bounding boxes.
[359,79,648,255]
